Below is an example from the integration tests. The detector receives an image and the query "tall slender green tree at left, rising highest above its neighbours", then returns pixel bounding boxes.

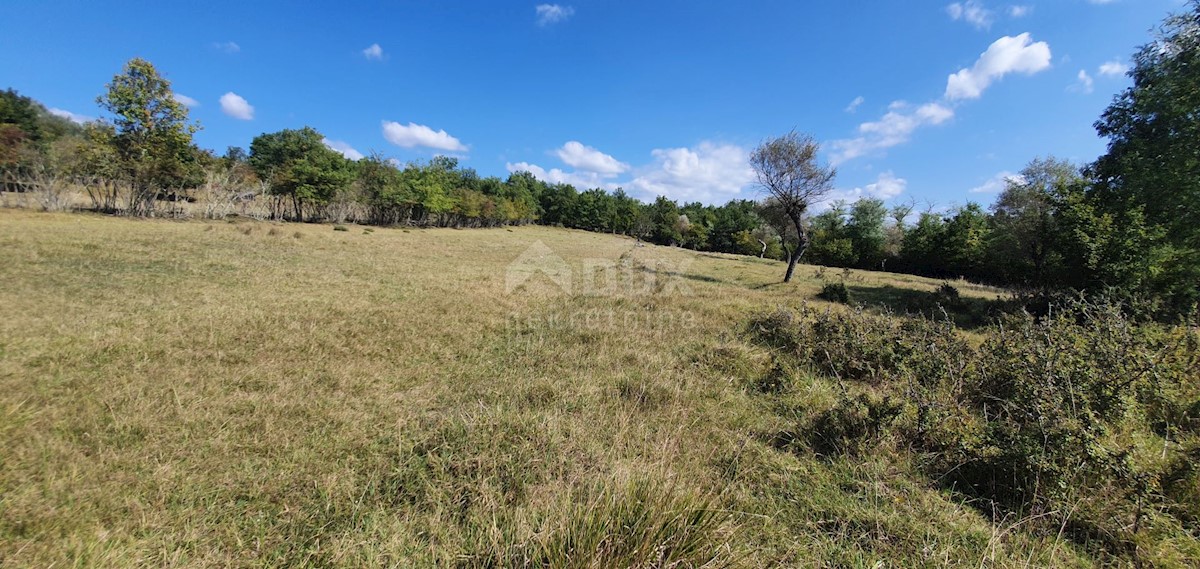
[96,58,202,215]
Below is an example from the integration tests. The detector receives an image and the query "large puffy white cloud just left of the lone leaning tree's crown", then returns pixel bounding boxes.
[629,142,755,203]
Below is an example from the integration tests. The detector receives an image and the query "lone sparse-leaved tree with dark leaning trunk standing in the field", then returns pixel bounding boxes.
[750,131,838,282]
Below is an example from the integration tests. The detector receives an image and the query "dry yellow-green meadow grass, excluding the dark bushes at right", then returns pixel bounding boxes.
[0,210,1142,568]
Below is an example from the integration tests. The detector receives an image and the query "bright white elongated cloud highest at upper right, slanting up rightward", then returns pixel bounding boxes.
[946,32,1050,101]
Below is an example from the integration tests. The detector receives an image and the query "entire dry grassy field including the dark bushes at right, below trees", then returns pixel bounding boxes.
[0,210,1200,567]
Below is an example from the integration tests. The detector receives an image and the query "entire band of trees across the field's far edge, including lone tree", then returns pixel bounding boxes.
[0,1,1200,317]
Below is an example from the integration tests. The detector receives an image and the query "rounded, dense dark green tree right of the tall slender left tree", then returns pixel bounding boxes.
[250,126,353,220]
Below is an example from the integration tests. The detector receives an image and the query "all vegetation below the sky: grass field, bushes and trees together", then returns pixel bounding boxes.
[0,2,1200,568]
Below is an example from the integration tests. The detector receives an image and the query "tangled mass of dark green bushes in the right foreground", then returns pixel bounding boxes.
[750,303,1200,561]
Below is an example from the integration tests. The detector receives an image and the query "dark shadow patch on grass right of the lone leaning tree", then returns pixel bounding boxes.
[846,285,1004,330]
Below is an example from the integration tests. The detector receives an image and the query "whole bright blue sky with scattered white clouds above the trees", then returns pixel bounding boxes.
[0,0,1183,209]
